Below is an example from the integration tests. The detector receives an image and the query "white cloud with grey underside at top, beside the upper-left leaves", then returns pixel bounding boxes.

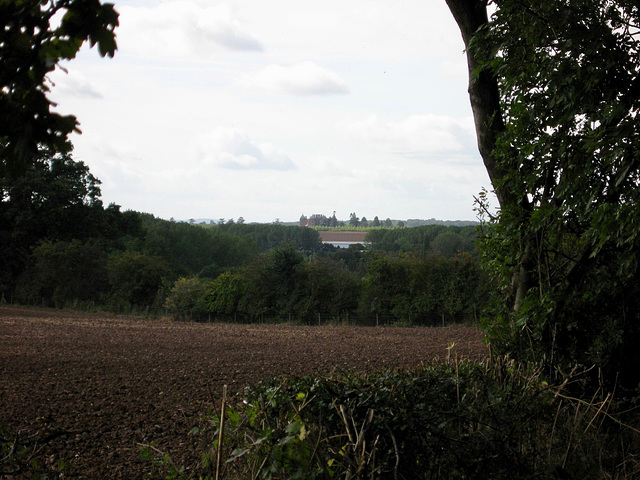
[117,0,262,59]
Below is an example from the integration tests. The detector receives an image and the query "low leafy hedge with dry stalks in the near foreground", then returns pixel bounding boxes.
[142,358,640,480]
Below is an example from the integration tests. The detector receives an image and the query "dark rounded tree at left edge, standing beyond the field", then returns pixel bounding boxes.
[0,150,142,302]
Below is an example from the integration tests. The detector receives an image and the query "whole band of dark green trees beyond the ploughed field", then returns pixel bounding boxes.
[0,151,487,324]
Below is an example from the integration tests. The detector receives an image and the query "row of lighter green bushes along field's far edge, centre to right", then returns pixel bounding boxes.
[159,242,490,325]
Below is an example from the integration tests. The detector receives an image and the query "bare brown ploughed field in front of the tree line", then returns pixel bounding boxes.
[0,306,487,479]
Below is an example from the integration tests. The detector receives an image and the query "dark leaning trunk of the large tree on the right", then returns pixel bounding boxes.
[445,0,535,311]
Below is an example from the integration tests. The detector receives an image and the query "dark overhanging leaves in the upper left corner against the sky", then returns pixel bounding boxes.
[0,0,118,177]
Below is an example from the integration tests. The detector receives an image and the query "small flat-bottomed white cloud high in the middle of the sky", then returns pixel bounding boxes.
[239,62,349,95]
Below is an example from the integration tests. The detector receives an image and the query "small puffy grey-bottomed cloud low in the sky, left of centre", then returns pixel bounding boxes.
[196,127,296,170]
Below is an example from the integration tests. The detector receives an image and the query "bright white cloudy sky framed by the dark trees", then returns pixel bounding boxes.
[50,0,490,222]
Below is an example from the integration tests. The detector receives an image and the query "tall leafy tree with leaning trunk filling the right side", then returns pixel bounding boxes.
[446,0,640,386]
